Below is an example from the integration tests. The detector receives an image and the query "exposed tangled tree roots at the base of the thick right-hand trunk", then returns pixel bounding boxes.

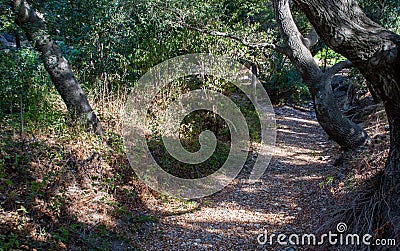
[317,171,400,250]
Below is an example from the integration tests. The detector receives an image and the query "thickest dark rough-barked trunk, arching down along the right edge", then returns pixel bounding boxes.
[295,0,400,235]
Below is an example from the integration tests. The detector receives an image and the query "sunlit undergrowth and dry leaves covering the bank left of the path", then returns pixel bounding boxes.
[0,51,260,250]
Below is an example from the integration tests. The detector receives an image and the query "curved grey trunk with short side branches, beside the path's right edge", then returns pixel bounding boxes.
[274,0,369,149]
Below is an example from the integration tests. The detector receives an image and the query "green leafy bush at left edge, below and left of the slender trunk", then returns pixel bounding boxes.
[0,48,63,131]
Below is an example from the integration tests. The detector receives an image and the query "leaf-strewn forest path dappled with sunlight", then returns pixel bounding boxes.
[135,106,337,250]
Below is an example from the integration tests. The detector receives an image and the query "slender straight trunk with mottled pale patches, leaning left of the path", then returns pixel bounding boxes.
[10,0,102,134]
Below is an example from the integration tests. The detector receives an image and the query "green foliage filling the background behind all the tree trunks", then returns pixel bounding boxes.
[0,0,394,129]
